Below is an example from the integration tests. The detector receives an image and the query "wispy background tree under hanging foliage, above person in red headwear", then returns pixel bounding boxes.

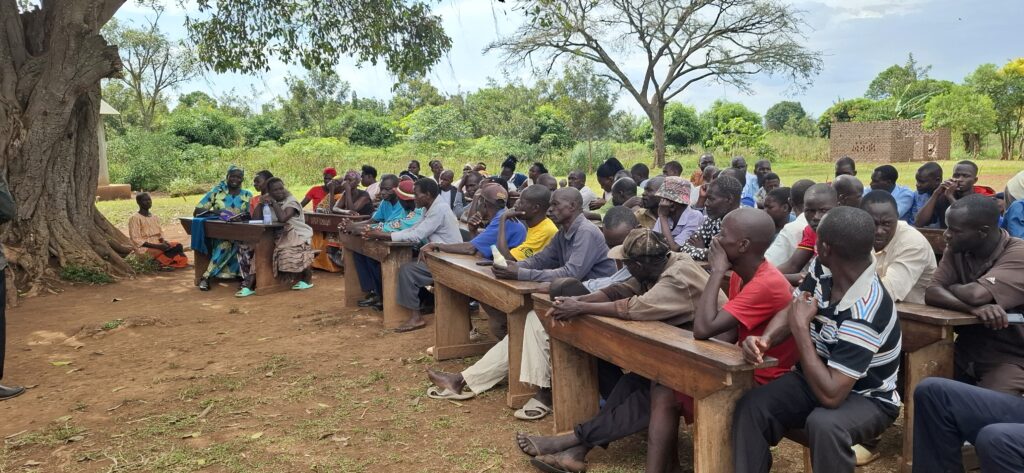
[278,70,349,136]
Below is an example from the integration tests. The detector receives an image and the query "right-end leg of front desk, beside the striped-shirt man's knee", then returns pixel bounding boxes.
[693,382,754,473]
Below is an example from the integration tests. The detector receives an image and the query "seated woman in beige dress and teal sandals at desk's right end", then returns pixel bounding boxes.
[266,177,313,291]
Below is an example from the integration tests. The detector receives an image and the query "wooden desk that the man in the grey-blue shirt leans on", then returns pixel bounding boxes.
[427,253,541,407]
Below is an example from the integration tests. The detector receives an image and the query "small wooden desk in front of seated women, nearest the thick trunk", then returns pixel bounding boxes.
[178,217,288,296]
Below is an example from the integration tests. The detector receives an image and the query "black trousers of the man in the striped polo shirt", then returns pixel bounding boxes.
[732,373,899,473]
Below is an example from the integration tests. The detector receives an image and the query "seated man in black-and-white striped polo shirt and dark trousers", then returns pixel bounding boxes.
[732,207,901,473]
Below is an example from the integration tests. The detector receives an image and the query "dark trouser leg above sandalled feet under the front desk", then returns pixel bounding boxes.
[573,370,650,448]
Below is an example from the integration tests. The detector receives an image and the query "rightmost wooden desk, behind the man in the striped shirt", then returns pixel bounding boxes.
[896,302,978,473]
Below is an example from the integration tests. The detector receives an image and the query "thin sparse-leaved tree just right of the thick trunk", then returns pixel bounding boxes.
[103,9,199,130]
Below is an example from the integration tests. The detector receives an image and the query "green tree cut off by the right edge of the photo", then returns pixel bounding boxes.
[965,58,1024,160]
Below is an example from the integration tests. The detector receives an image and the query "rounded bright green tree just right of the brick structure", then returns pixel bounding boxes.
[925,86,997,158]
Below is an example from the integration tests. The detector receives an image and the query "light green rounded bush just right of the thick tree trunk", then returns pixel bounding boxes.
[106,129,182,190]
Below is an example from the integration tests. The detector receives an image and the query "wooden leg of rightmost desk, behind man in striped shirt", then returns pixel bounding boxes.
[900,338,953,473]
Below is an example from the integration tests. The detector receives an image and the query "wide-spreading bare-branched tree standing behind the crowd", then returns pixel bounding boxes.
[485,0,821,167]
